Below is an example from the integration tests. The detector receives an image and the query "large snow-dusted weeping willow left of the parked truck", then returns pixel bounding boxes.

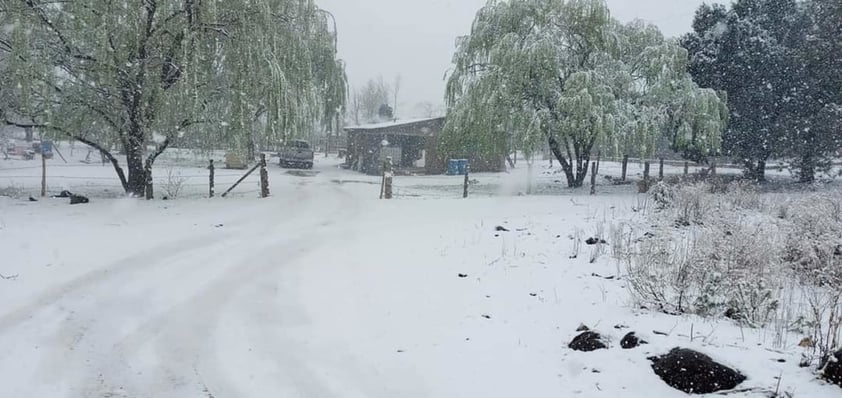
[0,0,346,196]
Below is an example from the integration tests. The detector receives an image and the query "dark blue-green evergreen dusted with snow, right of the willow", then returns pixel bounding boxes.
[682,0,842,182]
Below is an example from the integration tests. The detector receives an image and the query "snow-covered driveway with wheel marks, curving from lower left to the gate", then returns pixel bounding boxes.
[0,166,370,397]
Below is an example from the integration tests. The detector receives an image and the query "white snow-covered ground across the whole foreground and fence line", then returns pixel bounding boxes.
[0,147,842,398]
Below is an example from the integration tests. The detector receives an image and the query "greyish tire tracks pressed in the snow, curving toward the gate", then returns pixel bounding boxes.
[20,183,356,397]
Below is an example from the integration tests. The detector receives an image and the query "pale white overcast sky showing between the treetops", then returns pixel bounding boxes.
[316,0,722,118]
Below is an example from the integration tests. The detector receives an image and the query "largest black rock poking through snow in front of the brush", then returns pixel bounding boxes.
[649,348,746,394]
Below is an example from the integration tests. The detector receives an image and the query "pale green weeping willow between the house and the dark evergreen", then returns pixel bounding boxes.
[442,0,727,187]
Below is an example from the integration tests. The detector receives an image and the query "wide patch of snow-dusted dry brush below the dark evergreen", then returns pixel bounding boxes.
[624,181,842,364]
